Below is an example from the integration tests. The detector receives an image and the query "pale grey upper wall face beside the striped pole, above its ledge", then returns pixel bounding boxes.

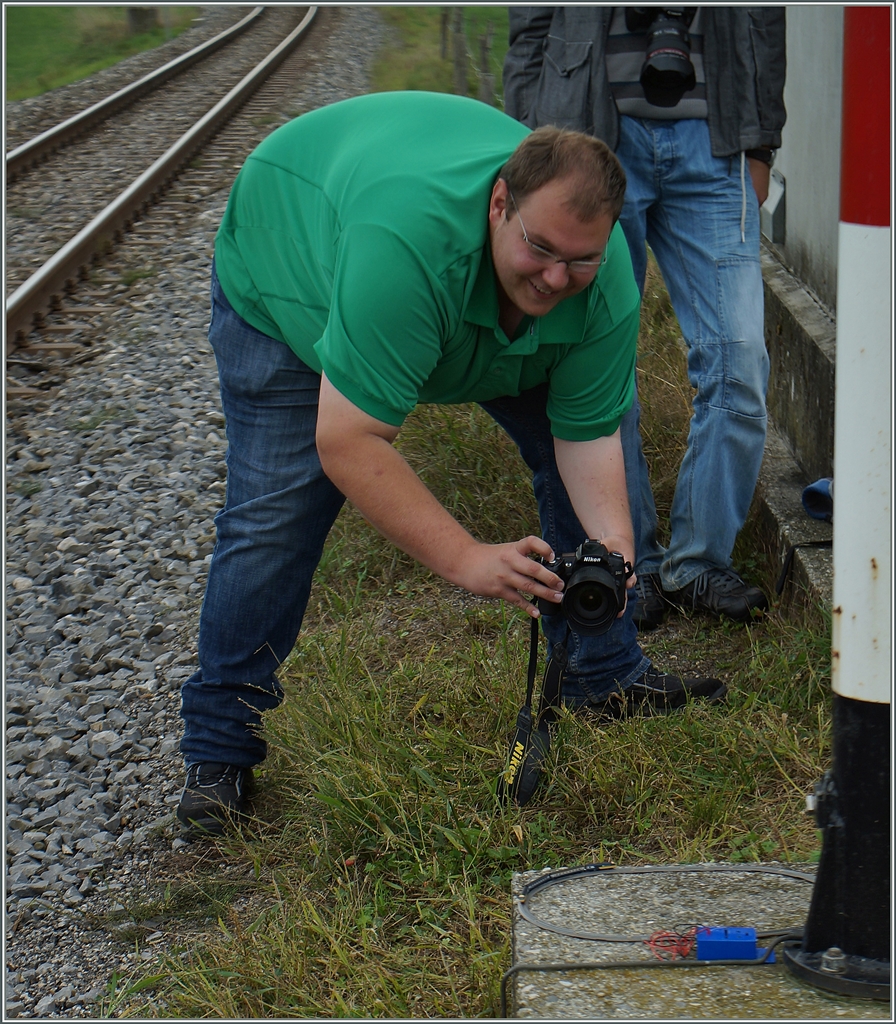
[770,4,843,312]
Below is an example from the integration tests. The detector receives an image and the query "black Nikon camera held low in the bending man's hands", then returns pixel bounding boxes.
[538,541,633,637]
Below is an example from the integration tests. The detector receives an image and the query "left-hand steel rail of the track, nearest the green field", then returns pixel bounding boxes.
[6,7,264,181]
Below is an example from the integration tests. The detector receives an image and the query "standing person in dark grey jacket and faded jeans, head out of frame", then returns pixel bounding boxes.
[504,4,785,629]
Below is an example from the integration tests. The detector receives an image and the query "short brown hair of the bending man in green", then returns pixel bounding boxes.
[498,125,626,223]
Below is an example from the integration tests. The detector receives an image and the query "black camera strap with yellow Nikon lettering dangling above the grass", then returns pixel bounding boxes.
[498,618,569,807]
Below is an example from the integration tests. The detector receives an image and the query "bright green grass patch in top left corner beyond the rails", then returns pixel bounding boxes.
[4,4,199,99]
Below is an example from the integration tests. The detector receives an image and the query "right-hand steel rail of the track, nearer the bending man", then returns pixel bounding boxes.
[6,7,318,348]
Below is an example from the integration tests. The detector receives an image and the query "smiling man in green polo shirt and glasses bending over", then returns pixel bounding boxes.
[178,93,725,831]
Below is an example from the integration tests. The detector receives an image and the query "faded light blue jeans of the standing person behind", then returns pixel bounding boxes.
[616,117,769,590]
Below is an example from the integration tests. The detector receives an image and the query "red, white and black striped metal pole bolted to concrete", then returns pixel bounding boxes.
[784,5,893,999]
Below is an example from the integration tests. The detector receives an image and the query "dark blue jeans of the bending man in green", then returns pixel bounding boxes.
[180,271,650,767]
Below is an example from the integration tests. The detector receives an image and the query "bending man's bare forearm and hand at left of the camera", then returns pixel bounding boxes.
[316,375,563,617]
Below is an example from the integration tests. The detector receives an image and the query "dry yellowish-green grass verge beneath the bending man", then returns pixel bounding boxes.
[94,8,829,1019]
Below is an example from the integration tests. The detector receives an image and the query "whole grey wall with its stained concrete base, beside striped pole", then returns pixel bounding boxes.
[757,4,843,606]
